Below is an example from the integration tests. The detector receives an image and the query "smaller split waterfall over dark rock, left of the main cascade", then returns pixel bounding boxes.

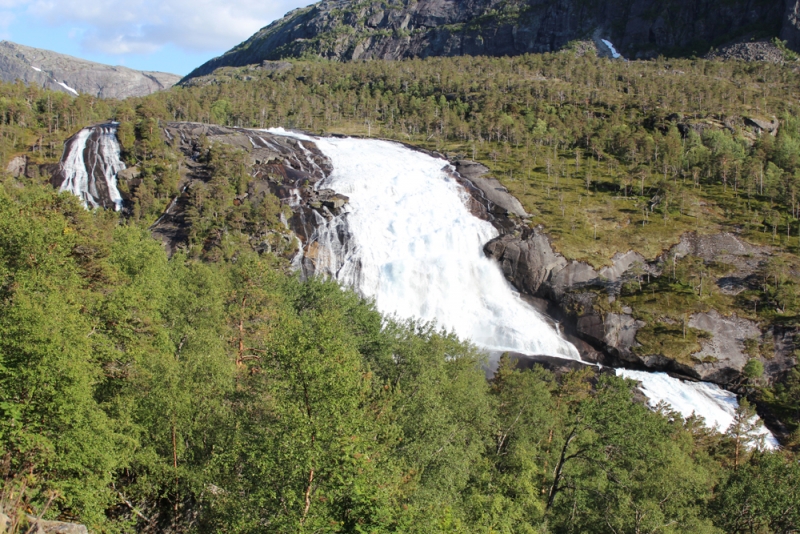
[55,123,125,211]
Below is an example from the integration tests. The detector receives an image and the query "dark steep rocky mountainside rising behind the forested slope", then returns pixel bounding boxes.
[184,0,800,78]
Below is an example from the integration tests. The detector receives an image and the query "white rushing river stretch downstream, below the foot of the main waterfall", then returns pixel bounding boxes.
[617,369,779,449]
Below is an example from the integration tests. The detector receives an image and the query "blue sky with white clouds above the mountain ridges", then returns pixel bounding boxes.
[0,0,314,75]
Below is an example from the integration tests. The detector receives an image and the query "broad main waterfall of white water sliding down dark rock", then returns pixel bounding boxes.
[271,130,580,360]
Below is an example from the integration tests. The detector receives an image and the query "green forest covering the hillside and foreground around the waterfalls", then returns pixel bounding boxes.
[0,52,800,534]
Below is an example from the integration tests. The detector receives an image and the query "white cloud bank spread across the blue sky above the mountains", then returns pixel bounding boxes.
[19,0,313,55]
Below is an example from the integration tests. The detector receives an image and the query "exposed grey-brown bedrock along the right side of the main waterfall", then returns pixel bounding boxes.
[485,227,796,386]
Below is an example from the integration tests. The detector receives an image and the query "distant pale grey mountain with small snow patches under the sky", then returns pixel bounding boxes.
[0,41,180,98]
